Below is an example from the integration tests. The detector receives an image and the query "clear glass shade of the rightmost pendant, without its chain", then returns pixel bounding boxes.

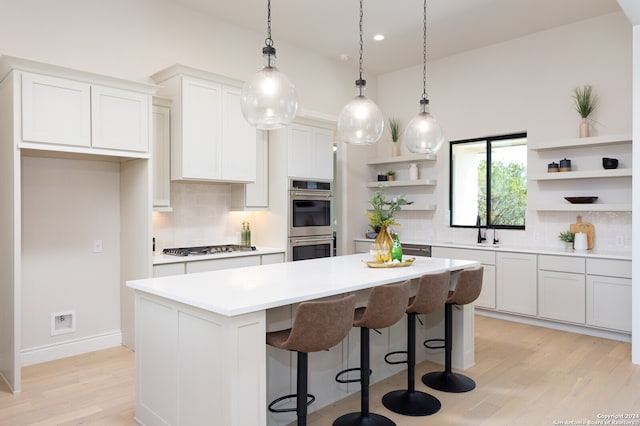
[404,99,444,154]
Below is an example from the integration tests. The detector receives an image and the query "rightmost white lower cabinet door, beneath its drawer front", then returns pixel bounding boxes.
[587,275,631,333]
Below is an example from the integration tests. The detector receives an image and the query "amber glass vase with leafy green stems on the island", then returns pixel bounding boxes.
[367,190,407,263]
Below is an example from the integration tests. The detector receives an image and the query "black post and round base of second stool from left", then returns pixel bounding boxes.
[333,327,396,426]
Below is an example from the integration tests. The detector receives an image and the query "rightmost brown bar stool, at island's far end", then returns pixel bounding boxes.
[422,267,483,393]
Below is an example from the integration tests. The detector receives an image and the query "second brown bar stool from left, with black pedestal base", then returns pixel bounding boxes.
[333,280,411,426]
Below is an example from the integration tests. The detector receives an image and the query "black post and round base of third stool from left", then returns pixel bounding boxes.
[382,313,441,416]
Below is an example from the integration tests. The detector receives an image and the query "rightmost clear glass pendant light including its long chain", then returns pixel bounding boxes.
[404,0,444,154]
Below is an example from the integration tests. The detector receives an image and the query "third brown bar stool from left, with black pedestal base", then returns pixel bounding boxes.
[382,271,451,416]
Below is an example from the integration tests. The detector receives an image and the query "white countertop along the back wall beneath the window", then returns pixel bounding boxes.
[354,238,631,260]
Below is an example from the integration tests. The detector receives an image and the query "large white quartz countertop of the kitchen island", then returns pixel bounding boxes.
[127,254,478,316]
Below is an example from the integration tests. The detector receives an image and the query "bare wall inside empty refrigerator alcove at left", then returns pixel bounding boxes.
[22,156,120,352]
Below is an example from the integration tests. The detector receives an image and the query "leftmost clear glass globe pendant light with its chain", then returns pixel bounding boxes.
[240,0,298,130]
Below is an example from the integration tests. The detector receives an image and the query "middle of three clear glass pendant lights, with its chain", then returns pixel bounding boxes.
[337,0,384,145]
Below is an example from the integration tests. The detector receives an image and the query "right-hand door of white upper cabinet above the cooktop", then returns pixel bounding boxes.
[221,86,256,182]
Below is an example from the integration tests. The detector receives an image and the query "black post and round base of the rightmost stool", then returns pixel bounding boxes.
[422,303,476,393]
